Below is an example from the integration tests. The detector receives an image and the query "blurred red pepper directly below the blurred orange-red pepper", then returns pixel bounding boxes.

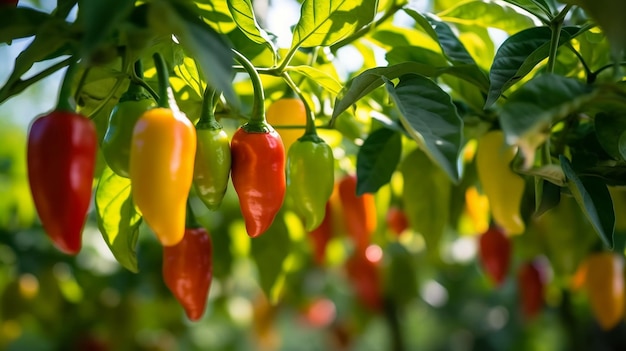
[346,249,383,311]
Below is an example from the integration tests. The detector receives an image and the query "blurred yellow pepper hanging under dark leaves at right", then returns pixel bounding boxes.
[476,130,525,235]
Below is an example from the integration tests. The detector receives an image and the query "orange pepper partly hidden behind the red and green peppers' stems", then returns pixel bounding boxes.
[266,87,307,151]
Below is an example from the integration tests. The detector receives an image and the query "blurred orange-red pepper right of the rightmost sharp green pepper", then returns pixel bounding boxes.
[338,174,377,251]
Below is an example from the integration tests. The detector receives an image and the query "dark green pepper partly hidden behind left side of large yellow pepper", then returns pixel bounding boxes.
[102,61,156,178]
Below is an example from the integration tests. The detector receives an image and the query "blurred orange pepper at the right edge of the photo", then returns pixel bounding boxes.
[585,252,625,330]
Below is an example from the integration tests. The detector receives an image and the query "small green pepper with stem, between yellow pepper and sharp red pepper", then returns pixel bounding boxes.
[193,87,231,210]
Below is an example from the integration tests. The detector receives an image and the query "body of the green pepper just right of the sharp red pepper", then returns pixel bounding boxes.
[287,134,335,231]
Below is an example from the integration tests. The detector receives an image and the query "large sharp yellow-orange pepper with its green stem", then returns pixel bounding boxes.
[130,54,196,246]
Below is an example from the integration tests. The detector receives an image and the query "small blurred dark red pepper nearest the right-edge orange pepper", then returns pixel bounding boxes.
[517,261,545,320]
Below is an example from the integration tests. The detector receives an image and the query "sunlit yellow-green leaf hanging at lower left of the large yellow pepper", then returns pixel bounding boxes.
[95,167,141,273]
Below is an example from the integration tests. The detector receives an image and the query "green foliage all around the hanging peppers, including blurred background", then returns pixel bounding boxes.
[0,0,626,350]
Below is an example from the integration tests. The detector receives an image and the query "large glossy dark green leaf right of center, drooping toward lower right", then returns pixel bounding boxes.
[385,74,463,183]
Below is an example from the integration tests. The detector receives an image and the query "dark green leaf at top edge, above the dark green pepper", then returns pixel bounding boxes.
[77,0,135,57]
